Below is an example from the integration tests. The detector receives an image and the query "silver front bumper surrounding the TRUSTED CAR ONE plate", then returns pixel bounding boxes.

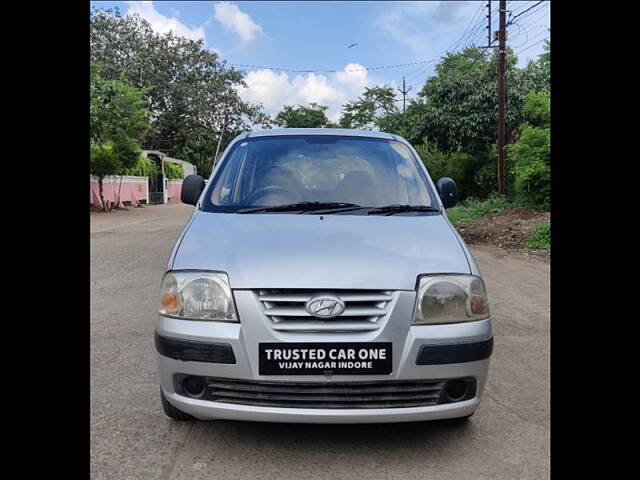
[155,292,492,423]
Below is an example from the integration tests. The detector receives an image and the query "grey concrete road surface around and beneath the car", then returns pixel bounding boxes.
[91,204,550,480]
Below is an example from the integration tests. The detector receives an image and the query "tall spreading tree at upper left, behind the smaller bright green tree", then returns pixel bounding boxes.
[90,9,270,175]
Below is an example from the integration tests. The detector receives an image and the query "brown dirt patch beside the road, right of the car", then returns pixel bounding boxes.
[456,207,551,260]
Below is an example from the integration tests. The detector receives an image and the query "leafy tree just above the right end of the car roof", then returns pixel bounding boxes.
[340,85,398,130]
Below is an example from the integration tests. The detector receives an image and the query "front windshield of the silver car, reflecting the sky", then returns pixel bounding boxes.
[205,135,437,212]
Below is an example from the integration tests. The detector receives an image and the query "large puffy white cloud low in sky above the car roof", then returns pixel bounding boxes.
[238,63,380,122]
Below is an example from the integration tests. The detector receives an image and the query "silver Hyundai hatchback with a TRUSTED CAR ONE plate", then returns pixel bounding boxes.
[155,129,493,423]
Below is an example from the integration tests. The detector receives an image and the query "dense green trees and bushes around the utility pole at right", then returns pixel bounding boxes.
[396,44,551,203]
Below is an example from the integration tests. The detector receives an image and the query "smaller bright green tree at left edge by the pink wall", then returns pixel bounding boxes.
[89,63,149,209]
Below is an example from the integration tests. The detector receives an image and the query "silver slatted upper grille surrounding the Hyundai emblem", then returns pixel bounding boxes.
[256,289,393,332]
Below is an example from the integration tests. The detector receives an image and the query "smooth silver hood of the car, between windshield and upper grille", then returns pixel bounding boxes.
[172,211,470,290]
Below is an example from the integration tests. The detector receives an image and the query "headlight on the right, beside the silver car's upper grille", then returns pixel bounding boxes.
[412,275,489,325]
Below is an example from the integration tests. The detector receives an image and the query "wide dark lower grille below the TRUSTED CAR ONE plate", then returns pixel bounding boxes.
[192,377,447,409]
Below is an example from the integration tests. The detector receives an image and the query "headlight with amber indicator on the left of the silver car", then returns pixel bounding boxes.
[159,271,238,322]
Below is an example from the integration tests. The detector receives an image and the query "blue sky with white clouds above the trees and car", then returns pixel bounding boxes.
[91,0,550,121]
